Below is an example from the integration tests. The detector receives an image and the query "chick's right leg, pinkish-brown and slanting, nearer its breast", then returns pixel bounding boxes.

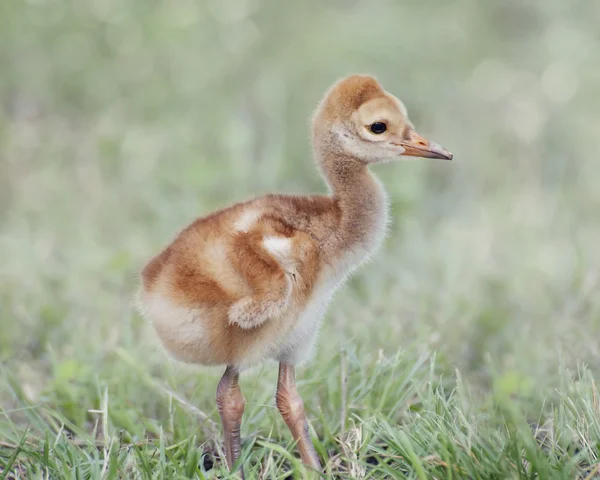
[276,363,321,470]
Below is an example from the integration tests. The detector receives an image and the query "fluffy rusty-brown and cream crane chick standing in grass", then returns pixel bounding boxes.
[137,74,452,478]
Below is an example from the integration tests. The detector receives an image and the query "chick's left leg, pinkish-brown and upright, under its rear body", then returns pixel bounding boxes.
[217,366,246,478]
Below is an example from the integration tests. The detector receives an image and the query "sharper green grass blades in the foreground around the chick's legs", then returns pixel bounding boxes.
[0,351,600,479]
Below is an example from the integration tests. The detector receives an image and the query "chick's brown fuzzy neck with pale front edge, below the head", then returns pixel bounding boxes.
[317,151,387,255]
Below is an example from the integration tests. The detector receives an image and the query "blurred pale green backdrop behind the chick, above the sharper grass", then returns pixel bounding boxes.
[0,0,600,476]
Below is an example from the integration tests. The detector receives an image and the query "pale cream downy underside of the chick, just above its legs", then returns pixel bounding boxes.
[138,266,343,369]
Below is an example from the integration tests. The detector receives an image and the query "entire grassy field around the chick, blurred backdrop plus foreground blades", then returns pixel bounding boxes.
[0,0,600,480]
